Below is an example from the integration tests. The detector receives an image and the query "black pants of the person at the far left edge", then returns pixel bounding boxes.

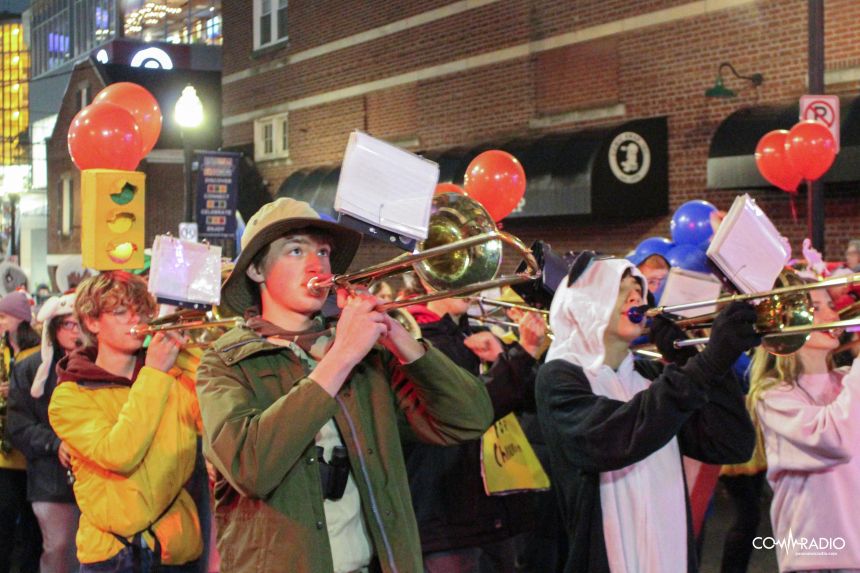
[0,468,42,573]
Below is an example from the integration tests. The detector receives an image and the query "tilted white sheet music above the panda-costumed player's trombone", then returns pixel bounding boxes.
[707,195,791,293]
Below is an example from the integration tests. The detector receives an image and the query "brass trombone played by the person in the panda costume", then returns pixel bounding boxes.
[628,269,860,355]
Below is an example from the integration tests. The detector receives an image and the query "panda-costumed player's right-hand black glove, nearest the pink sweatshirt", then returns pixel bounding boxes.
[701,302,761,375]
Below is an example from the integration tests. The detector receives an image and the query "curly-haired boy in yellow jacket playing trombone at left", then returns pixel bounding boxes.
[48,271,203,573]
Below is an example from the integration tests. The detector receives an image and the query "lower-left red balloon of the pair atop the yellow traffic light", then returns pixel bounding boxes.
[68,102,143,171]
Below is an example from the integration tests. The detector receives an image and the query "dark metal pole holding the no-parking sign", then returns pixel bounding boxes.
[806,0,824,250]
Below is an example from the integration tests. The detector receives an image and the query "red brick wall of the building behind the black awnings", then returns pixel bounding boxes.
[223,0,860,265]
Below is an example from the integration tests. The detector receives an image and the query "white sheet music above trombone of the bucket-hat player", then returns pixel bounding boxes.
[334,131,439,239]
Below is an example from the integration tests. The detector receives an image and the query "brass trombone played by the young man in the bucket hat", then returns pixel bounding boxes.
[307,193,541,312]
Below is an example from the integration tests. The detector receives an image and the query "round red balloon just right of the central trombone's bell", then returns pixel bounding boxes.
[463,149,526,221]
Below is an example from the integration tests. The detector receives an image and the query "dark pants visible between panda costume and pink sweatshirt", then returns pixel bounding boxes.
[720,472,766,573]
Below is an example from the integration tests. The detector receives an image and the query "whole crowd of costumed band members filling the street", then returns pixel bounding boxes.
[0,202,860,573]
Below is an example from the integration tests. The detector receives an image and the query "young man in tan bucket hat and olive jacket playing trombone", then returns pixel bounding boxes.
[197,198,493,573]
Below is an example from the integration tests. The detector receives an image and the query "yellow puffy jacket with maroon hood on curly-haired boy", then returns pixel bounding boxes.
[48,349,203,565]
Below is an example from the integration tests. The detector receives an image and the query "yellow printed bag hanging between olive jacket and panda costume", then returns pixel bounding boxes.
[481,413,549,495]
